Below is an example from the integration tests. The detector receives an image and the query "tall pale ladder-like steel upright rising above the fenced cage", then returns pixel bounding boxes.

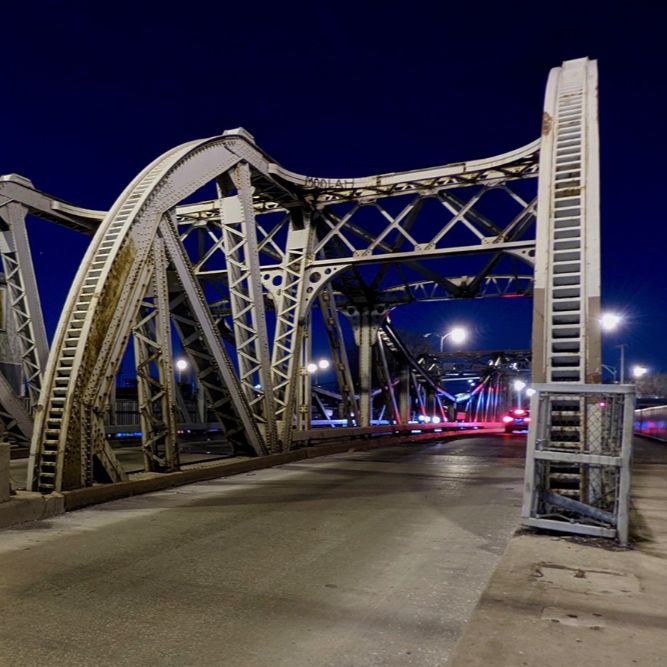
[533,58,602,383]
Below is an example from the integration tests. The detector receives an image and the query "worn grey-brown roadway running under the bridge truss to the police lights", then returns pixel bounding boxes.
[0,435,525,667]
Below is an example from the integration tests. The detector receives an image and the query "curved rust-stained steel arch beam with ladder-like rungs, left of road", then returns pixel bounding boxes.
[29,137,264,490]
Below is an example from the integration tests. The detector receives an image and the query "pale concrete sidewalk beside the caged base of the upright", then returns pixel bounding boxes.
[448,463,667,667]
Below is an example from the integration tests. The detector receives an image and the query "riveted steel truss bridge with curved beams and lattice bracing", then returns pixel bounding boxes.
[0,59,600,493]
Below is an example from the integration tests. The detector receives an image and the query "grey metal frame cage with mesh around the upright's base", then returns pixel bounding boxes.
[522,384,635,544]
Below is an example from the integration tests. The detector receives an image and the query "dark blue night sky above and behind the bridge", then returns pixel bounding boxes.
[0,1,667,372]
